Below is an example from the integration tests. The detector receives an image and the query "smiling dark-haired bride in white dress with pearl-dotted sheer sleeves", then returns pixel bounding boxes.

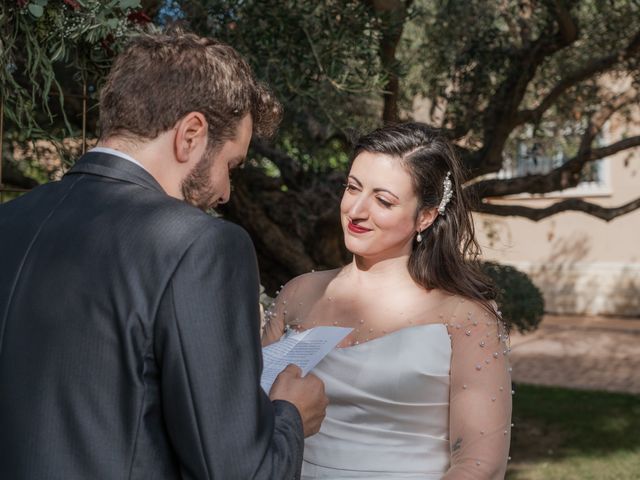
[263,123,512,480]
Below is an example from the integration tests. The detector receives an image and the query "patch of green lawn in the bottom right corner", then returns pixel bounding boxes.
[506,385,640,480]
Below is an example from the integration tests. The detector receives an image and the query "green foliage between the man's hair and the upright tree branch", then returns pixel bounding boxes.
[192,0,386,172]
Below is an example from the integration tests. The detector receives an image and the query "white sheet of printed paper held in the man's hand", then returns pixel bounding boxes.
[260,327,353,393]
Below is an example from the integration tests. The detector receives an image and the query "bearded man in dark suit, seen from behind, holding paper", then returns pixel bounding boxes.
[0,32,327,480]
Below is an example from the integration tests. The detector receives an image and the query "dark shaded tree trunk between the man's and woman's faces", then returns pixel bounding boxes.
[222,167,350,295]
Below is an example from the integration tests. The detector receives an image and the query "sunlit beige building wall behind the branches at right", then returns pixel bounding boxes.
[475,125,640,317]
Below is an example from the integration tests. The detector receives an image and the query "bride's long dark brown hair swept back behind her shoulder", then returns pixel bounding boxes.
[353,122,496,312]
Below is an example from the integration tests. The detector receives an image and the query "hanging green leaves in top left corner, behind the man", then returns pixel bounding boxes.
[0,0,146,139]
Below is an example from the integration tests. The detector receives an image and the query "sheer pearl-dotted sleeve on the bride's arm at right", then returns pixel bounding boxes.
[443,300,512,480]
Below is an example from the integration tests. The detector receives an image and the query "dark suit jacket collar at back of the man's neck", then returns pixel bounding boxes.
[66,152,165,193]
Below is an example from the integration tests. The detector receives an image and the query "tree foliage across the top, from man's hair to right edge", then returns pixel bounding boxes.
[195,0,640,182]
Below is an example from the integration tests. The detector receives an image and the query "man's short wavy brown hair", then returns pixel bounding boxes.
[100,30,282,148]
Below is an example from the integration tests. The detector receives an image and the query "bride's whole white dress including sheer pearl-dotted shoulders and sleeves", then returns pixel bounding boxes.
[265,280,513,480]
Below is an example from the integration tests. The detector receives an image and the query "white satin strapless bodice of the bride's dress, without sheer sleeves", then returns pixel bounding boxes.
[302,323,451,480]
